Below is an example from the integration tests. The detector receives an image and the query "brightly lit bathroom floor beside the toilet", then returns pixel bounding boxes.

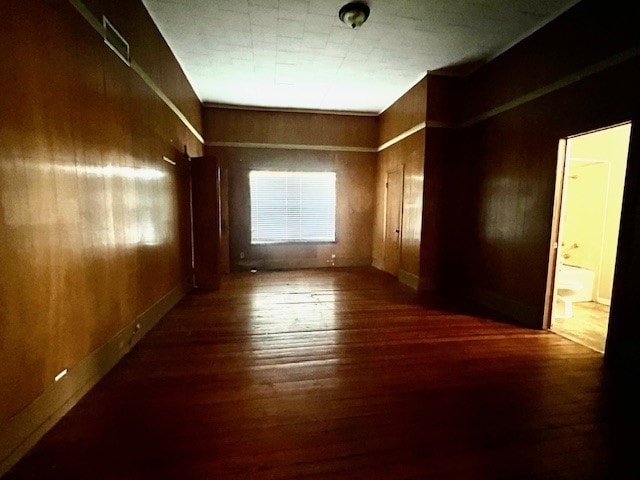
[551,302,609,353]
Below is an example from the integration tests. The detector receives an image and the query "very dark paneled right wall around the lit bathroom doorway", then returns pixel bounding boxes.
[441,1,640,350]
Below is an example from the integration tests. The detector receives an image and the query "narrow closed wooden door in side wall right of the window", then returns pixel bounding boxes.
[384,168,404,277]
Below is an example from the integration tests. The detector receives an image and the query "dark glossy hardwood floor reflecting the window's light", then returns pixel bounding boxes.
[6,269,640,480]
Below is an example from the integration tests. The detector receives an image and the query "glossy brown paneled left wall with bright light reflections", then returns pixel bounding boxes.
[0,0,202,436]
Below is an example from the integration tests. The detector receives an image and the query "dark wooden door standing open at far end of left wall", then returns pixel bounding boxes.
[191,157,222,290]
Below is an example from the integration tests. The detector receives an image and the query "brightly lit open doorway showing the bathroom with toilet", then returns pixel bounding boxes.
[548,123,631,353]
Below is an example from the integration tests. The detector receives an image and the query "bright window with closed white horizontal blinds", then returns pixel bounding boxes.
[249,170,336,244]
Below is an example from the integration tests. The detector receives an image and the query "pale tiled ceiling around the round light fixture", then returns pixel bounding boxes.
[141,0,577,113]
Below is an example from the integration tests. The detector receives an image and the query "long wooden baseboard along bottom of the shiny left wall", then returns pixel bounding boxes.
[0,285,190,477]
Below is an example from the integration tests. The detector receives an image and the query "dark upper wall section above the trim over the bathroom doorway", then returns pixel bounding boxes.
[461,0,639,124]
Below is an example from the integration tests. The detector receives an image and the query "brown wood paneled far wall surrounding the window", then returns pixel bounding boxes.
[203,107,377,270]
